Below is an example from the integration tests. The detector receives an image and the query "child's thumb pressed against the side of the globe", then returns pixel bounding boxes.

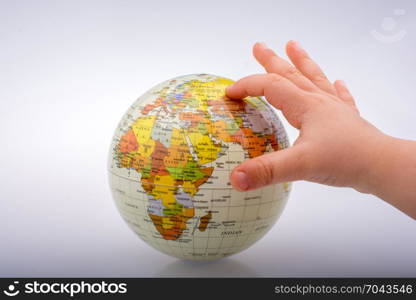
[230,145,306,191]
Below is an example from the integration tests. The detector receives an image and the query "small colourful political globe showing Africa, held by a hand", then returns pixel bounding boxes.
[108,74,290,260]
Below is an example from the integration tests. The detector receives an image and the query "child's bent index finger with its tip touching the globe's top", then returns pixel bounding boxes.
[226,74,309,128]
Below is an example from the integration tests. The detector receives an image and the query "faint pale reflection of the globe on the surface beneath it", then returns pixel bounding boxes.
[154,258,257,277]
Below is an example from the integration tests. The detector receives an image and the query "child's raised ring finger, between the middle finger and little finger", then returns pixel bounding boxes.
[286,41,336,95]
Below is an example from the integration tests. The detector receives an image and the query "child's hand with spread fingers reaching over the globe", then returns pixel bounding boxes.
[227,42,416,218]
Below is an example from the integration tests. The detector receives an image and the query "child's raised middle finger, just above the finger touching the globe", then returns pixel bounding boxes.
[253,43,317,91]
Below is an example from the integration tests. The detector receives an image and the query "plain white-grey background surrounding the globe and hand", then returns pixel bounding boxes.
[0,0,416,276]
